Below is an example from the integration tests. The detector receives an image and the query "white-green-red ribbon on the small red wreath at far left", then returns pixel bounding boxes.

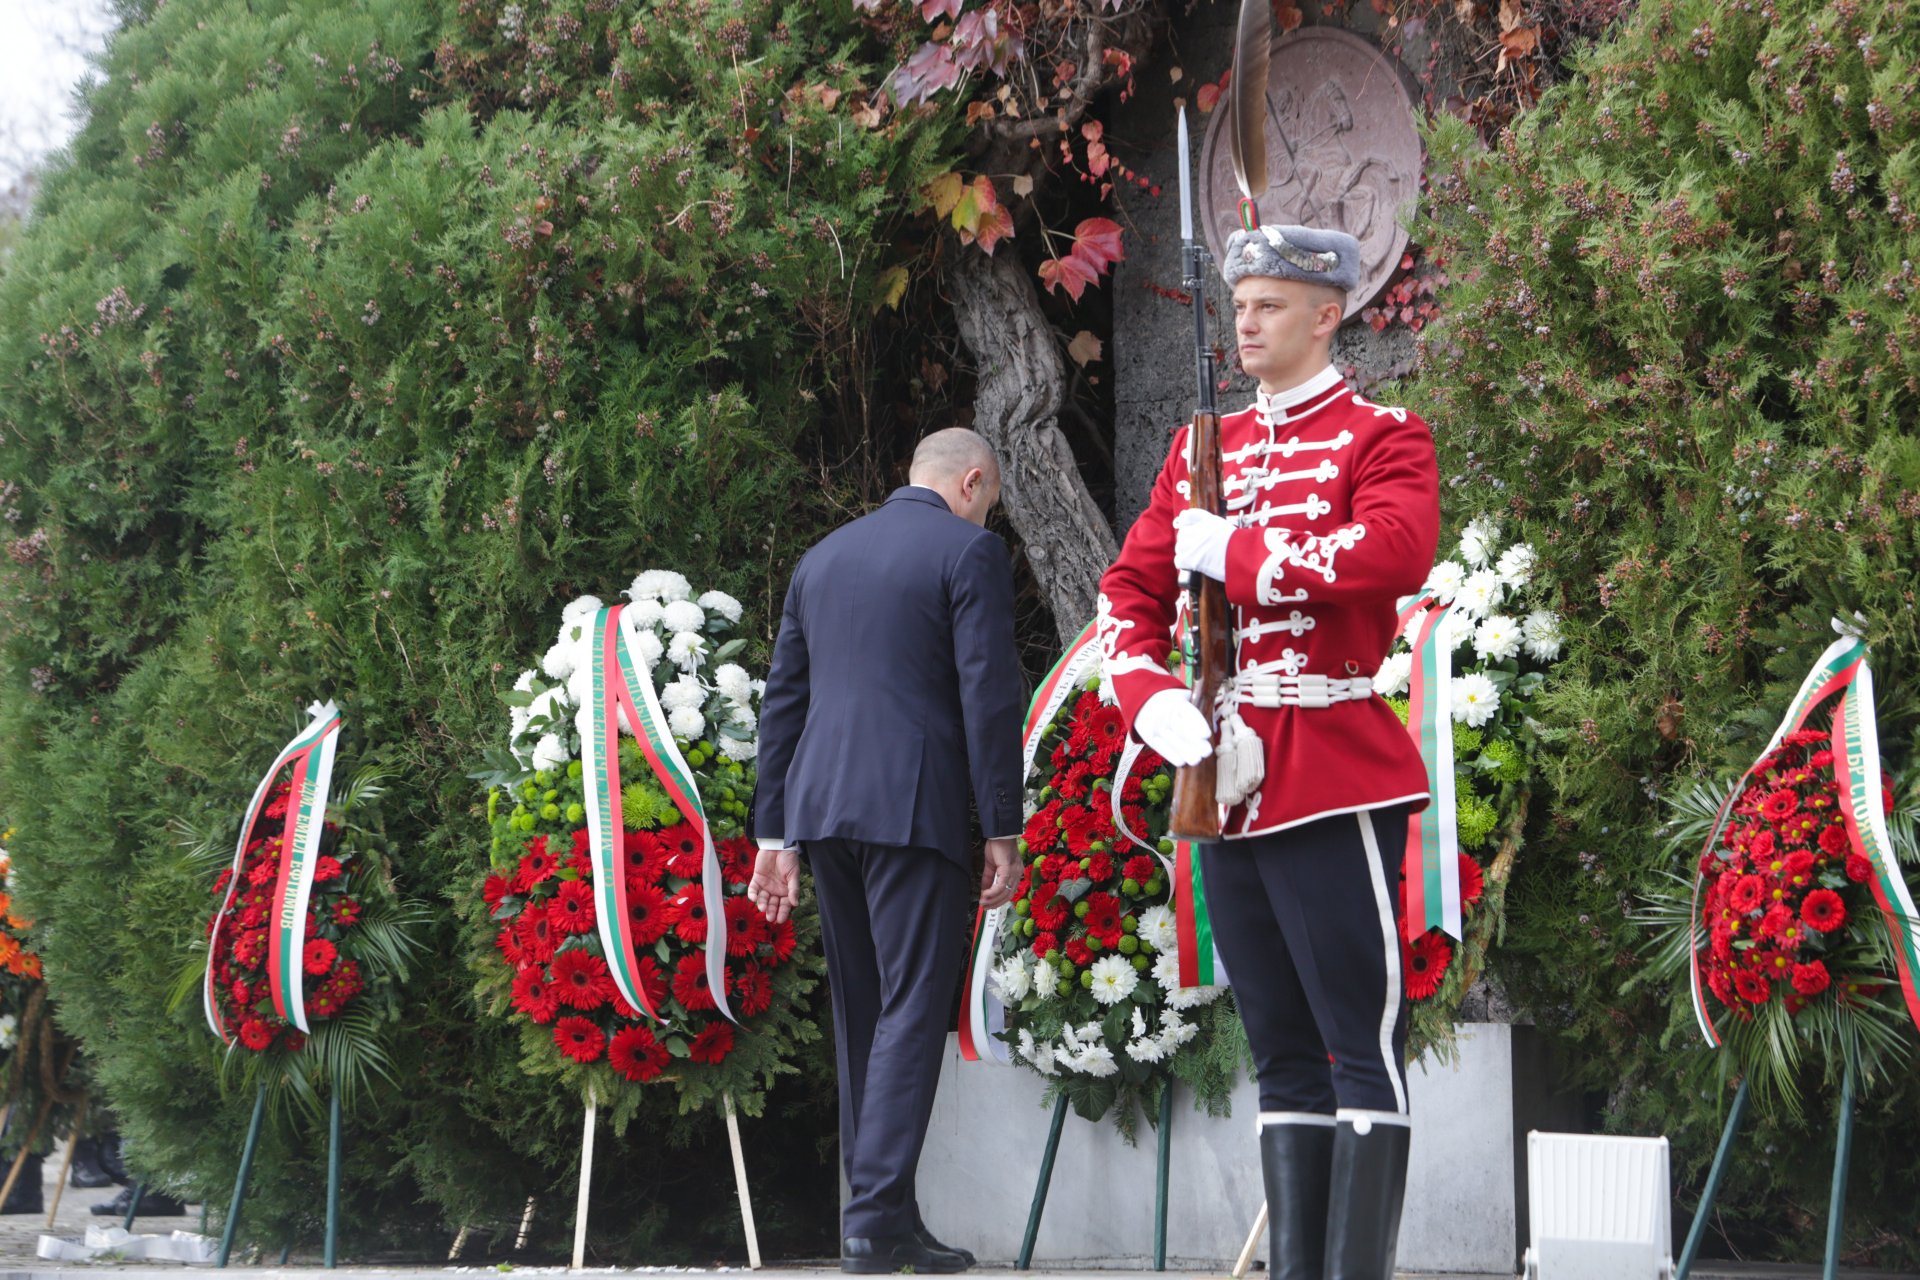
[204,702,340,1042]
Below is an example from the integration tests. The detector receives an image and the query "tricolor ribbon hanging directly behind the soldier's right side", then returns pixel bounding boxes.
[1400,591,1461,942]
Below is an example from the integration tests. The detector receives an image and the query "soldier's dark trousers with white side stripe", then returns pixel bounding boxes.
[1200,804,1407,1115]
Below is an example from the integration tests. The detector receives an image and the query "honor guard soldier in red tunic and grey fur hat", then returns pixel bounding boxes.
[1098,226,1440,1280]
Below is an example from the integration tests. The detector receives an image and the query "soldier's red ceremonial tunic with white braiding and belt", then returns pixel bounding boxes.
[1096,368,1440,839]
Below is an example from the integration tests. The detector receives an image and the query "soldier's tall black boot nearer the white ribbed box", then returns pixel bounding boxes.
[1325,1107,1413,1280]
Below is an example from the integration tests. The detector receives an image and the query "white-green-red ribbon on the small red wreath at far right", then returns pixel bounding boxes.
[1688,618,1920,1048]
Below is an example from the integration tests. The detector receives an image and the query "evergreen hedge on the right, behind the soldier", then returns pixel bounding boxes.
[1404,0,1920,1265]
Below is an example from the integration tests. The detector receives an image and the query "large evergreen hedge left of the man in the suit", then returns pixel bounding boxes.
[0,0,948,1261]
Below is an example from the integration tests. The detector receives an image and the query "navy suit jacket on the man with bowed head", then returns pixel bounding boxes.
[753,486,1023,865]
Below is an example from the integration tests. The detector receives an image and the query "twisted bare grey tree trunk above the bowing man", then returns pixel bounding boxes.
[947,249,1116,645]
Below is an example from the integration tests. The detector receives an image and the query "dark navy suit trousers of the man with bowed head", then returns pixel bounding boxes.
[803,841,970,1236]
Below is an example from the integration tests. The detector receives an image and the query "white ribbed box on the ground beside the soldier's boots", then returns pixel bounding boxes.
[1526,1132,1674,1280]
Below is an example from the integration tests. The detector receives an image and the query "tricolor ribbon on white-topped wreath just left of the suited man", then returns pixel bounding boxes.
[574,604,733,1021]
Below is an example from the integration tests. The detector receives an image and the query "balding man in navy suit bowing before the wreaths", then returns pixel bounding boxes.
[747,428,1023,1272]
